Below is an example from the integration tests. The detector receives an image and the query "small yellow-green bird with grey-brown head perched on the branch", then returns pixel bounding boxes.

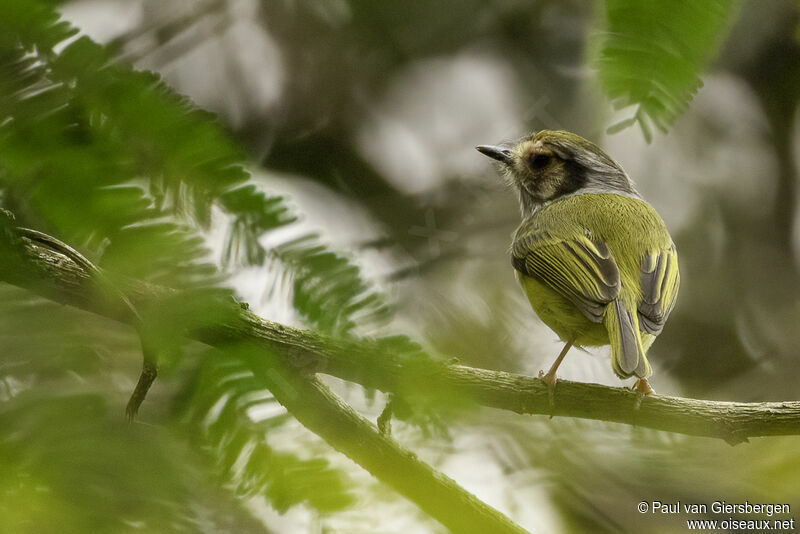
[477,130,680,394]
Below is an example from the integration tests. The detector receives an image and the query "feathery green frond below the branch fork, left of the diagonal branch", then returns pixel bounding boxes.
[177,350,353,513]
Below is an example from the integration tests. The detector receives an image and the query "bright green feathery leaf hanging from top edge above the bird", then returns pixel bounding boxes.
[592,0,738,141]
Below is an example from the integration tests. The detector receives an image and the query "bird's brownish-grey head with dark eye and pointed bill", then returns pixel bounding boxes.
[476,130,639,215]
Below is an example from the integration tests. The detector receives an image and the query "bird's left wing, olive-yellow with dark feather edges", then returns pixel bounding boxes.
[512,232,620,323]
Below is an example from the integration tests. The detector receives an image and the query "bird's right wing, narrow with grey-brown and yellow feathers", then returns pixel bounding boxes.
[636,245,681,335]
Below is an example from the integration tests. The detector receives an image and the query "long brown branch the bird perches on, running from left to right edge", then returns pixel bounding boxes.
[0,241,800,450]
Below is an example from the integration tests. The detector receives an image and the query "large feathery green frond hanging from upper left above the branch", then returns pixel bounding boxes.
[0,0,388,340]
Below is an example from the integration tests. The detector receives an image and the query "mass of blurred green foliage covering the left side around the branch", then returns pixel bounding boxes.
[0,1,400,532]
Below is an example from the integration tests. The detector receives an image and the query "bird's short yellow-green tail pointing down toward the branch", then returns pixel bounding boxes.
[603,299,653,378]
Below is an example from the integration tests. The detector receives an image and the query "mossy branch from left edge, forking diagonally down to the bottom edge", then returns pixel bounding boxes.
[0,237,527,534]
